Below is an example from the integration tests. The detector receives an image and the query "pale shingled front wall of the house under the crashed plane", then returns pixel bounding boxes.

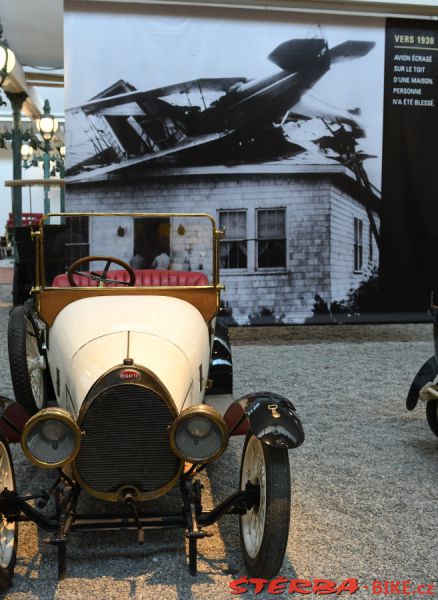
[67,174,370,324]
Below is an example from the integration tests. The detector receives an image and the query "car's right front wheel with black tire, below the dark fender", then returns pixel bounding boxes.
[240,433,291,579]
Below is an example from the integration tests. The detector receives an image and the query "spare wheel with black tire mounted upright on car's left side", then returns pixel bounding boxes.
[8,306,47,415]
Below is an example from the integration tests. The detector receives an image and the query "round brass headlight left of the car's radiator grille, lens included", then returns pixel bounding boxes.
[21,408,81,469]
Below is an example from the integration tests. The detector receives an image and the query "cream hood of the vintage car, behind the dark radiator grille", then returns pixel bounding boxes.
[47,296,210,416]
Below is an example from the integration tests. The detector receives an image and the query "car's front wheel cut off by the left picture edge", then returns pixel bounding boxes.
[0,431,18,590]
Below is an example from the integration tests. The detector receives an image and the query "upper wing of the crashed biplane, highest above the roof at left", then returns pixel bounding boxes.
[67,77,246,113]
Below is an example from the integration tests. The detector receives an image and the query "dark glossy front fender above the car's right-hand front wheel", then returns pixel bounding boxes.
[224,392,304,448]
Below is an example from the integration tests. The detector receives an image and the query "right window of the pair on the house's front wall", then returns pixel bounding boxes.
[256,208,286,269]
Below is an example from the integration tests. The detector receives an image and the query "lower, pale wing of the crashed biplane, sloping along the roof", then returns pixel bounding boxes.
[65,131,233,183]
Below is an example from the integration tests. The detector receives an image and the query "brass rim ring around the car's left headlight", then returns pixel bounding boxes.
[21,406,81,469]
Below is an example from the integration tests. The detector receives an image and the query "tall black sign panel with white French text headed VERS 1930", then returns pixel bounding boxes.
[380,19,438,312]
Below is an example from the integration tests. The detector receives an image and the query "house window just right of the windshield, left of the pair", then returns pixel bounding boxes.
[219,210,248,269]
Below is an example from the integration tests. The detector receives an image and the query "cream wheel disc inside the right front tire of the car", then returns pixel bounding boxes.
[240,436,266,559]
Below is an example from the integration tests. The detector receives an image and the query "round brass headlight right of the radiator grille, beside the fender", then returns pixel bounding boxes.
[170,404,228,463]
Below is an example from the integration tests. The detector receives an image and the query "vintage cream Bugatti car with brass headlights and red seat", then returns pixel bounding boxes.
[0,213,304,587]
